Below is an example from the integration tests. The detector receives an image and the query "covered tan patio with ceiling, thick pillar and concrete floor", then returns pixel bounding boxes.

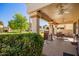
[28,3,79,56]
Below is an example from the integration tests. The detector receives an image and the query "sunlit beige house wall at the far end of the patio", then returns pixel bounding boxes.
[56,24,73,36]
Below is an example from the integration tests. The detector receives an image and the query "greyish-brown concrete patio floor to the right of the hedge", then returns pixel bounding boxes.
[43,39,77,56]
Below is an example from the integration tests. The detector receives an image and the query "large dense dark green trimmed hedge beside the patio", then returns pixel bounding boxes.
[0,33,43,56]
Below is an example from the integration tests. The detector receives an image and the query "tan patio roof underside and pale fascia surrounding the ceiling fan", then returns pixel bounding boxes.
[28,3,79,24]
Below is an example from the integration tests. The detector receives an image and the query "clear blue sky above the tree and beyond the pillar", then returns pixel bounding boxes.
[0,3,47,26]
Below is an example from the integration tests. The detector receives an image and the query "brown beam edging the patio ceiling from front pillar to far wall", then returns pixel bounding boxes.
[38,11,74,24]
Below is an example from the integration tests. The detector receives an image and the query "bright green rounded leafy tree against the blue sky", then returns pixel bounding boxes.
[8,14,29,32]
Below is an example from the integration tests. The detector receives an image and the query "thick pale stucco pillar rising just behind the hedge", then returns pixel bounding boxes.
[30,12,39,33]
